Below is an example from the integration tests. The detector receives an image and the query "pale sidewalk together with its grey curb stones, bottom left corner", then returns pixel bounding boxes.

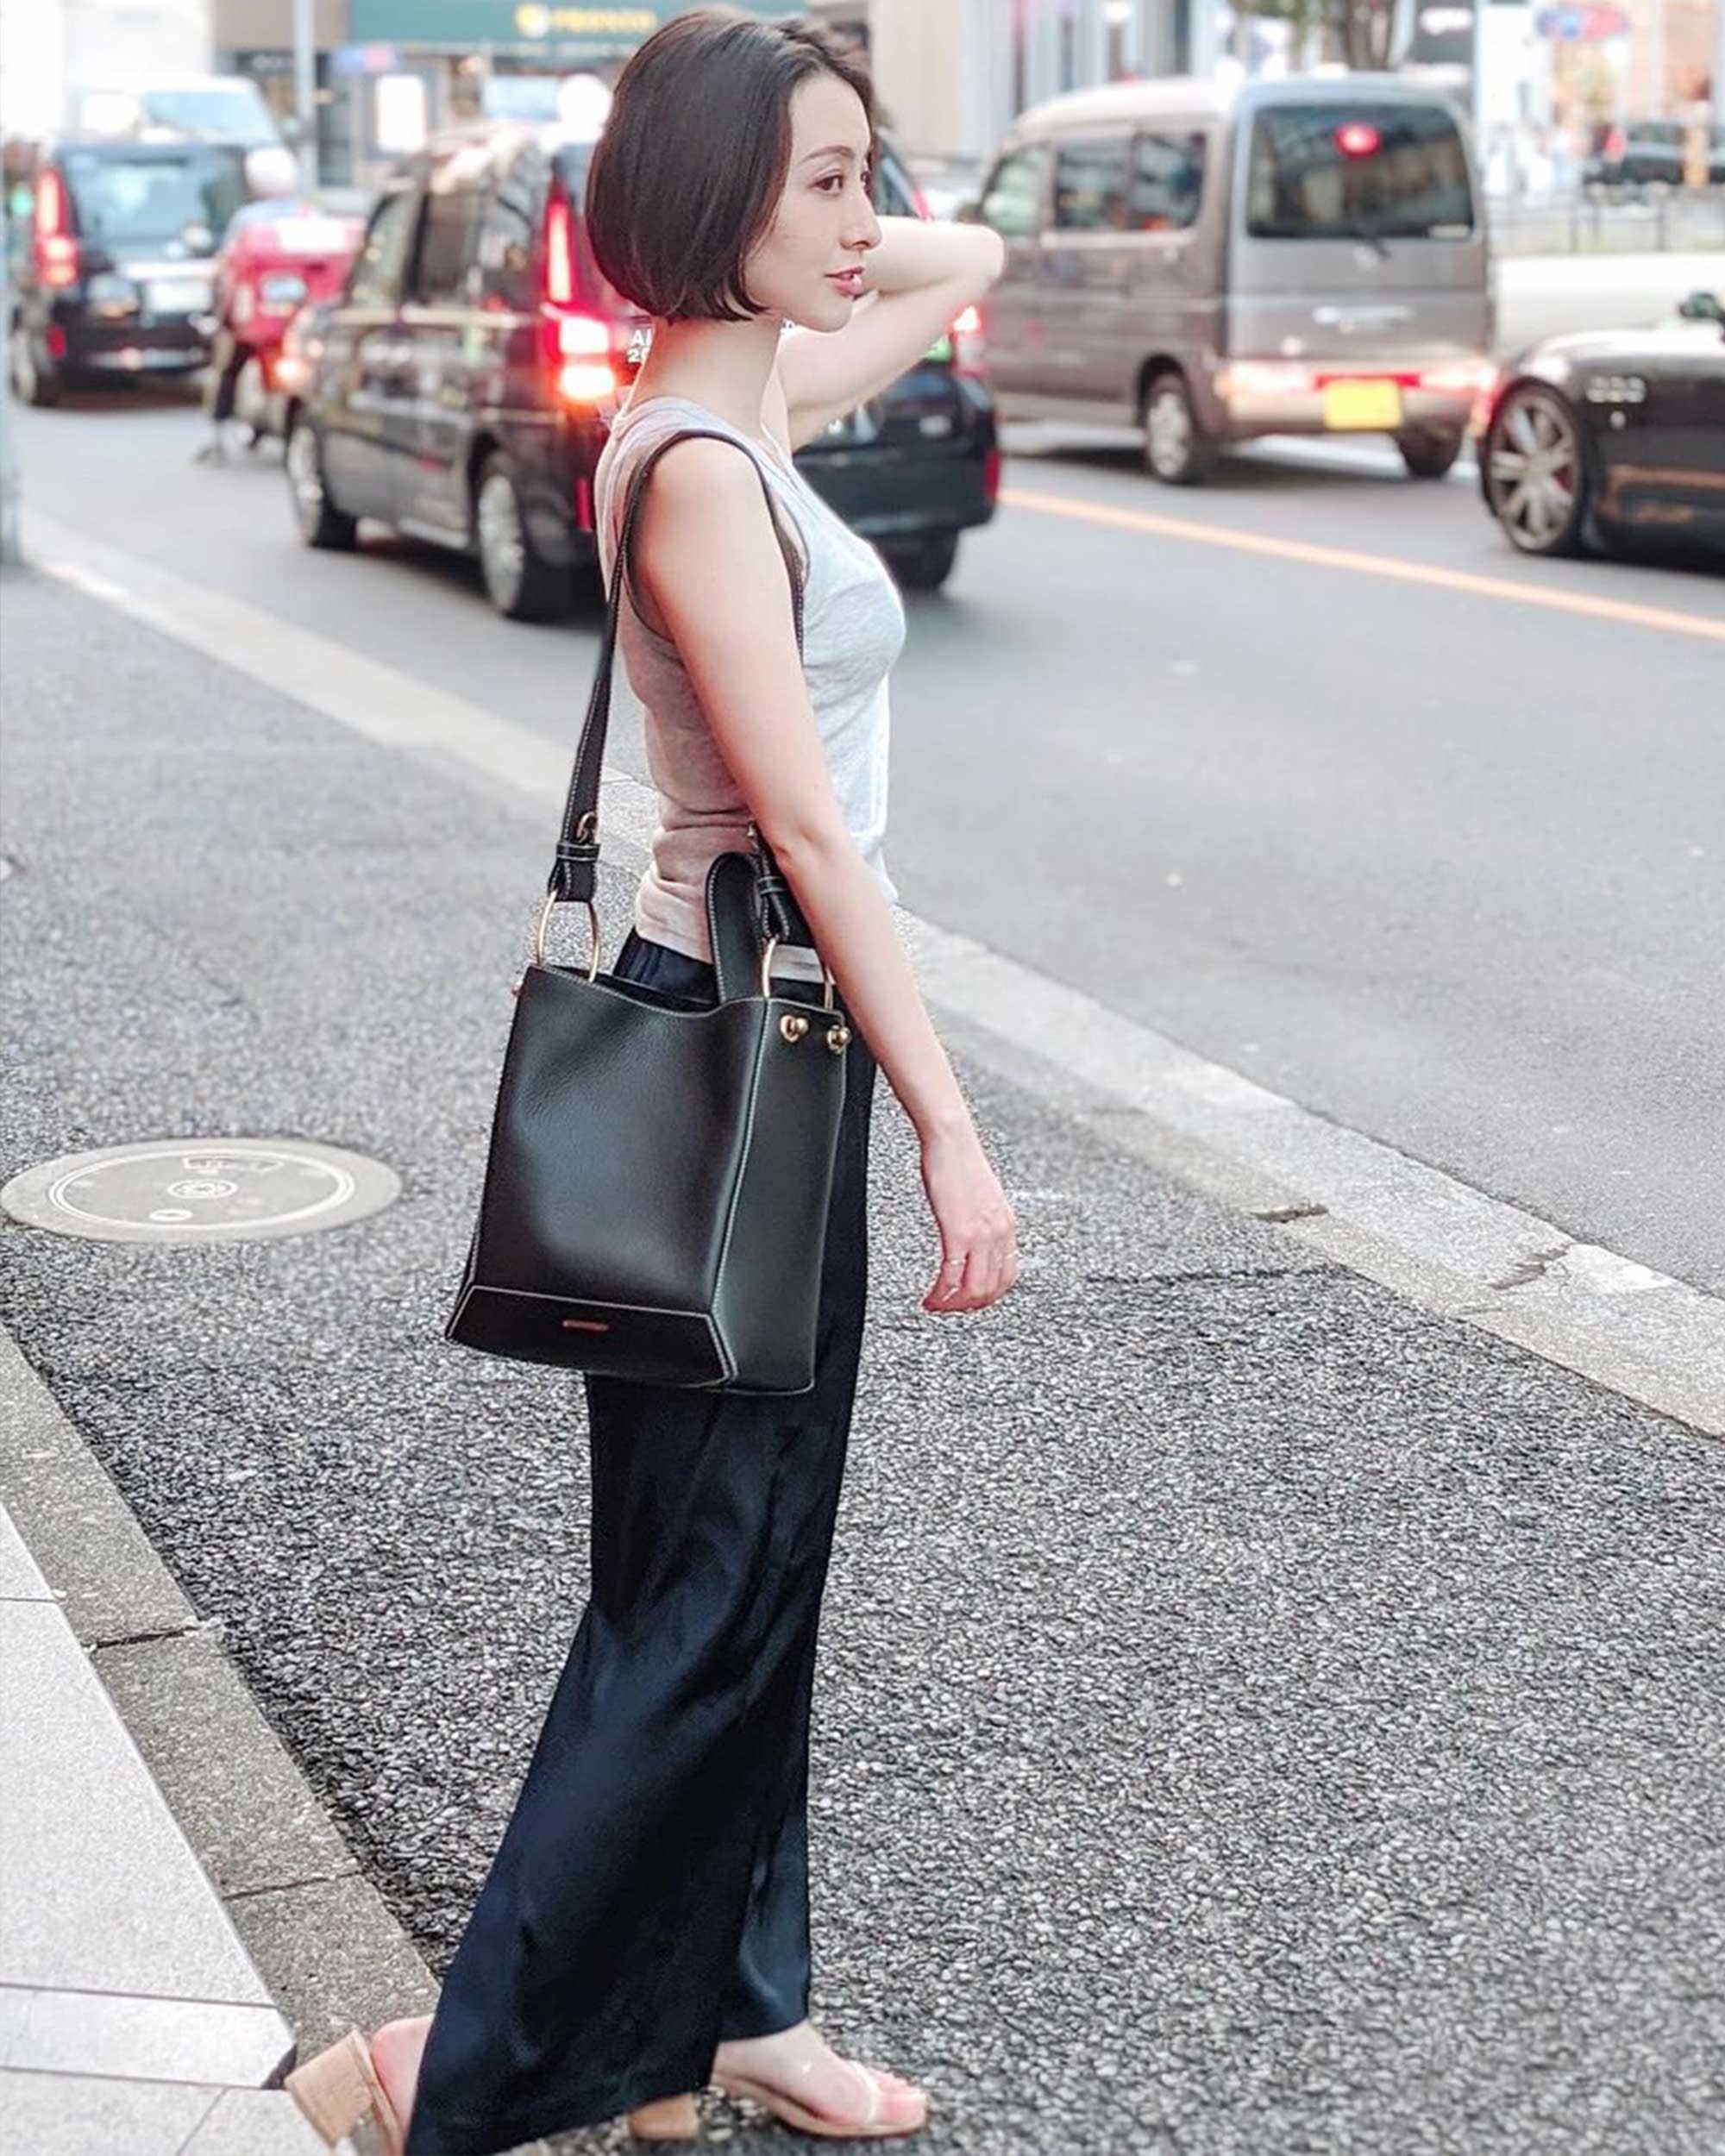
[0,1328,436,2156]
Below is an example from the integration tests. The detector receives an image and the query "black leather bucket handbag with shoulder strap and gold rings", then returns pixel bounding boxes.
[447,429,852,1393]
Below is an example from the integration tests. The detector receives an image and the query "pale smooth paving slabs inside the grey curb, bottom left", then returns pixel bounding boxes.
[0,1332,322,2156]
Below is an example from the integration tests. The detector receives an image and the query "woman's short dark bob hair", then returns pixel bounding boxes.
[586,7,875,322]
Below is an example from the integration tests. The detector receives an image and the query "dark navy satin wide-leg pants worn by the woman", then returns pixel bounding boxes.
[408,934,875,2156]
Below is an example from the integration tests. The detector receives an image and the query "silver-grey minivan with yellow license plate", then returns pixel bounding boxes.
[962,76,1492,486]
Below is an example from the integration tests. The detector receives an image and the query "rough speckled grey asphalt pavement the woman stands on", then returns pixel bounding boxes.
[0,578,1725,2156]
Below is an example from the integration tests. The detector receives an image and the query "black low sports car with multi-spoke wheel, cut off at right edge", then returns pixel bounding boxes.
[1475,291,1725,555]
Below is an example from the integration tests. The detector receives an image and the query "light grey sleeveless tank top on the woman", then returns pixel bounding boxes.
[593,397,904,979]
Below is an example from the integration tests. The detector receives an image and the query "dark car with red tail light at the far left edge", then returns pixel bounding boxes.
[11,138,246,405]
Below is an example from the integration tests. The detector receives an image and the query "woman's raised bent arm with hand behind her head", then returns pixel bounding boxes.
[766,218,1005,448]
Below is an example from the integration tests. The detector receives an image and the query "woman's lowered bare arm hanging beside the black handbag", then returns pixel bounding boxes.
[634,440,1018,1313]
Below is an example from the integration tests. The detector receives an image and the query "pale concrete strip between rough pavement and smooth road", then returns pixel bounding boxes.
[26,513,1725,1436]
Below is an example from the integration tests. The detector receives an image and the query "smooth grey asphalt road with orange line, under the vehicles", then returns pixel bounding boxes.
[20,266,1725,1289]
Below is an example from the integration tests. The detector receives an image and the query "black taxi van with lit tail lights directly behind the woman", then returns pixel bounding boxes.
[287,128,999,621]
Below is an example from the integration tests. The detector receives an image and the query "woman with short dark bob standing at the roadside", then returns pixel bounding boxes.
[289,9,1018,2156]
